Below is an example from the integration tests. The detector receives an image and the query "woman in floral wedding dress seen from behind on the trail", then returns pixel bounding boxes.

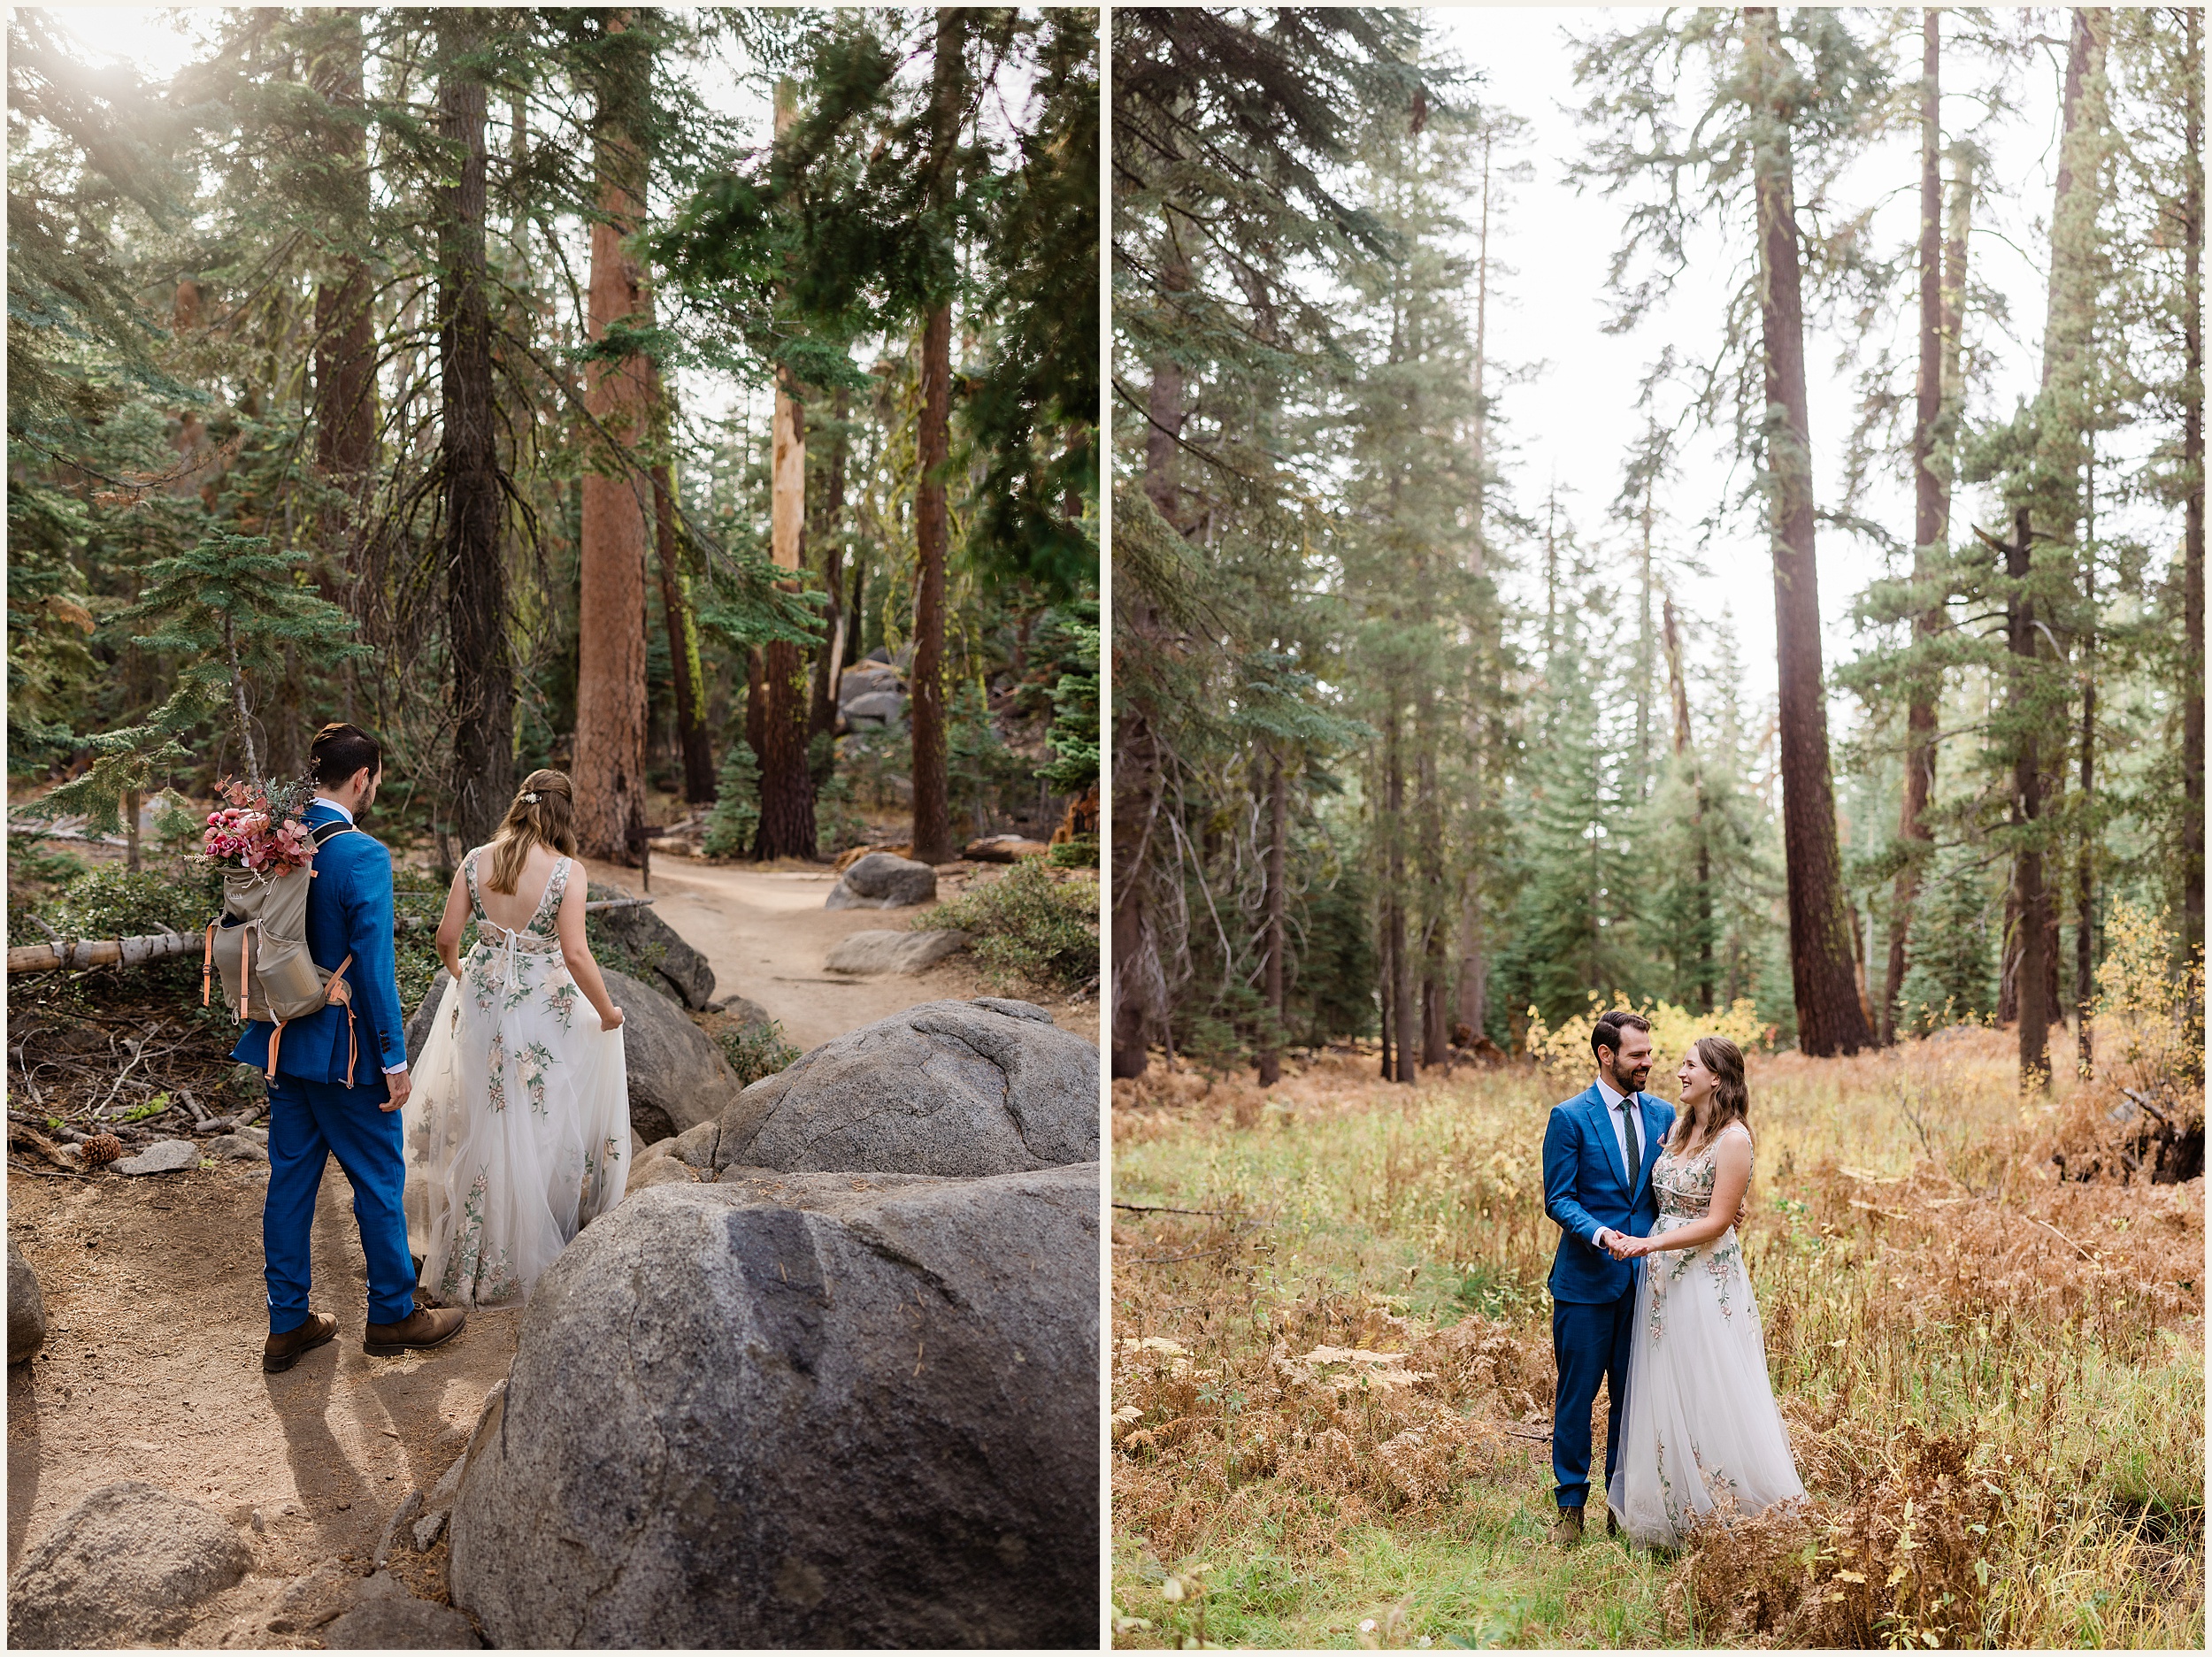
[403,770,631,1305]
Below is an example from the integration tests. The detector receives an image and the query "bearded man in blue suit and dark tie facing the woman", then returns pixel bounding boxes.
[1544,1011,1675,1546]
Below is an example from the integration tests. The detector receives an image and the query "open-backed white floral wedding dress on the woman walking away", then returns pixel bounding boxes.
[403,849,631,1305]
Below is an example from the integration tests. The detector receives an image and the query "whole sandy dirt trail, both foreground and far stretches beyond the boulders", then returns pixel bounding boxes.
[7,858,1097,1648]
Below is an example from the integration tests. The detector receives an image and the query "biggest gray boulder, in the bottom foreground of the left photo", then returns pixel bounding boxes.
[447,1163,1100,1648]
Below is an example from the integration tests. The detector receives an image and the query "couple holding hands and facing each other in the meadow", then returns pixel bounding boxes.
[1544,1011,1805,1546]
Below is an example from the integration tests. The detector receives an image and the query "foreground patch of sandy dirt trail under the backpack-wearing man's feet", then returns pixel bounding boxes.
[7,1163,520,1645]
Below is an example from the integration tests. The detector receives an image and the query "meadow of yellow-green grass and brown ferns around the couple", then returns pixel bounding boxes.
[1113,1029,2206,1648]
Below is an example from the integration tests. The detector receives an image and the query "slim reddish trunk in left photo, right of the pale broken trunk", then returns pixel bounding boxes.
[907,7,967,863]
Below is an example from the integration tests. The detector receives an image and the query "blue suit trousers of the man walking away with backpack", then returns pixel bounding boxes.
[261,1070,414,1334]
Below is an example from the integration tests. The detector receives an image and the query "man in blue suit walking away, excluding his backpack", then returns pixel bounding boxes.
[230,725,465,1374]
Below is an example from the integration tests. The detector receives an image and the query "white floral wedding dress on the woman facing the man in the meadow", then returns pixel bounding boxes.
[1606,1124,1805,1546]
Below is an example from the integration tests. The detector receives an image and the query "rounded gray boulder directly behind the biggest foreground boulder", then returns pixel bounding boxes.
[715,1000,1100,1177]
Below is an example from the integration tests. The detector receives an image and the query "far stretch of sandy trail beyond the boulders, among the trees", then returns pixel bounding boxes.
[587,858,1097,1051]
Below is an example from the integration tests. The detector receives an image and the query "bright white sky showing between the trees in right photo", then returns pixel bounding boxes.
[1436,7,2172,717]
